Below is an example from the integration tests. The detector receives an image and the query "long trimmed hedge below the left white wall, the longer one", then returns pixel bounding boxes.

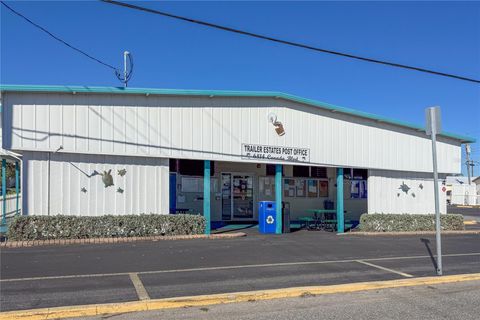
[7,214,205,240]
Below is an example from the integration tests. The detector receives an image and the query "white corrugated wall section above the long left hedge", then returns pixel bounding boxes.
[23,152,169,215]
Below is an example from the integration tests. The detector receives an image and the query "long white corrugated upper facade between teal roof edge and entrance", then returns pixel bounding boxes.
[4,93,461,173]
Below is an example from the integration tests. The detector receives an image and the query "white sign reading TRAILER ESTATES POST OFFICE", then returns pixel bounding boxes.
[242,143,310,162]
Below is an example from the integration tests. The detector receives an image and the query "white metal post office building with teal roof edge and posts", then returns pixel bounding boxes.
[0,85,474,232]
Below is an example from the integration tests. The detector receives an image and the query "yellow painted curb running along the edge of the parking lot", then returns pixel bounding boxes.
[0,273,480,320]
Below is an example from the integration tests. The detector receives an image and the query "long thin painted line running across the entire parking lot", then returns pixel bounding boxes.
[0,252,480,283]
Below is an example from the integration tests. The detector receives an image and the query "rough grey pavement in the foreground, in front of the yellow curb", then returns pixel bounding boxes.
[68,281,480,320]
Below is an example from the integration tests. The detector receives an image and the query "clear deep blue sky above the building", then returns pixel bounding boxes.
[0,1,480,175]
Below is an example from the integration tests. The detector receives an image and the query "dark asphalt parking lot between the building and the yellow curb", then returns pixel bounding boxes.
[0,231,480,311]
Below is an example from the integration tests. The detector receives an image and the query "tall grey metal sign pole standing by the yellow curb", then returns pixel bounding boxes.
[429,108,443,276]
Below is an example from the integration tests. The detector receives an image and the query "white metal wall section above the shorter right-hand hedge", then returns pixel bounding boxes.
[368,170,447,214]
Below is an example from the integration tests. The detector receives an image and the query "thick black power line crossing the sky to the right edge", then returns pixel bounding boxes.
[100,0,480,83]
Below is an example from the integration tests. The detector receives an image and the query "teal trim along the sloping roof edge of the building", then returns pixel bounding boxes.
[0,85,476,143]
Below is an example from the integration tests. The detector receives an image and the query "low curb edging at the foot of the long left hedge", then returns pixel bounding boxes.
[0,232,247,248]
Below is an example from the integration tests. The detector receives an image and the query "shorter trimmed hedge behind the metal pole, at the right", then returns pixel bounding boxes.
[360,213,465,232]
